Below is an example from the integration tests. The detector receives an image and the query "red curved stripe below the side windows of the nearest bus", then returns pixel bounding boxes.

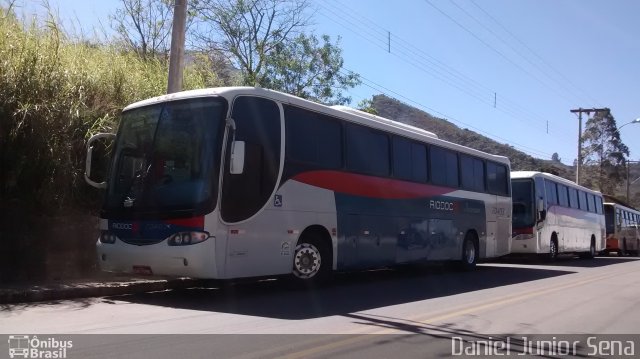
[293,171,454,199]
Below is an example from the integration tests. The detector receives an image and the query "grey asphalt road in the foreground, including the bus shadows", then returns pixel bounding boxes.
[0,257,640,358]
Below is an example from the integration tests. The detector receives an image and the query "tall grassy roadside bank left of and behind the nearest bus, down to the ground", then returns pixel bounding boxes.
[0,6,219,282]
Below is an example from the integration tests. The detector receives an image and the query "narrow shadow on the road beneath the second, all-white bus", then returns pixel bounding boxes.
[492,255,640,268]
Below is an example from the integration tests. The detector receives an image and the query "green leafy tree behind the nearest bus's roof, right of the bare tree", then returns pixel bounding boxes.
[262,34,360,105]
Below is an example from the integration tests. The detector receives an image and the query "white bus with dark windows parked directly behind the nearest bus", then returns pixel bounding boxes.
[511,171,605,259]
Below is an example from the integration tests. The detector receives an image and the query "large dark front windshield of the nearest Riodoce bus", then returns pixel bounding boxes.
[105,98,226,217]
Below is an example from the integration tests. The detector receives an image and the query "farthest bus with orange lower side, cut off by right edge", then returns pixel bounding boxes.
[602,202,640,256]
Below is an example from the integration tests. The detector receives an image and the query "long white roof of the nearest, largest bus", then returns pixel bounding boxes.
[124,87,510,164]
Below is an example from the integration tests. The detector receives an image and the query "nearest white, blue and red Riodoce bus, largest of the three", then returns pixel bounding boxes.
[86,87,511,280]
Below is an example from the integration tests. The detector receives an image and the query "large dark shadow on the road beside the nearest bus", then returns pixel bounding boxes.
[105,265,574,319]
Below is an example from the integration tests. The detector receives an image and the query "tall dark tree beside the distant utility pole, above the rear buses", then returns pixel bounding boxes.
[582,111,629,194]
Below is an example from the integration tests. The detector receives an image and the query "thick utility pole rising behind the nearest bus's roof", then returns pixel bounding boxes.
[167,0,187,93]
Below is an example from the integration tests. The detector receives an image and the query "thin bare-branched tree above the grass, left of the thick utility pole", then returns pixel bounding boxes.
[109,0,173,59]
